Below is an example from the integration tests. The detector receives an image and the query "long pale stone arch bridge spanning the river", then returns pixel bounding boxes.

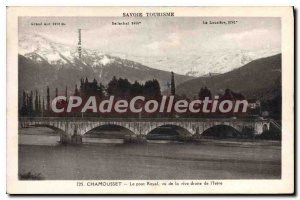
[19,117,271,144]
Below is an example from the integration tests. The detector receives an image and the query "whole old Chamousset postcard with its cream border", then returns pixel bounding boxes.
[8,7,294,193]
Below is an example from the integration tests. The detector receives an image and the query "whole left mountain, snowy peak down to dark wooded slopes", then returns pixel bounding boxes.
[19,34,191,96]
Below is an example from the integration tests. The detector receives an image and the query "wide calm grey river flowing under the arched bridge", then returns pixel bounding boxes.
[19,128,281,180]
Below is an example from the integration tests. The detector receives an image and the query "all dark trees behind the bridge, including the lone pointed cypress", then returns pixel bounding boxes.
[20,72,253,117]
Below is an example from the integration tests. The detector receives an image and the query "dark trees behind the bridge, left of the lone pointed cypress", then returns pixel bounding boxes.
[19,76,162,116]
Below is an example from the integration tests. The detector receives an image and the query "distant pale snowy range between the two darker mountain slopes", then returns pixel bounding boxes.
[112,49,280,77]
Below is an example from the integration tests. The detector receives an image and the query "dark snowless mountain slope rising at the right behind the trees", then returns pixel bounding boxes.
[176,54,281,99]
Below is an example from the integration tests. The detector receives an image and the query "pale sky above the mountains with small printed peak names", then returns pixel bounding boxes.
[19,17,281,56]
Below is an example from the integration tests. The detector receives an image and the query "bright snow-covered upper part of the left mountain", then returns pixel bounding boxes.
[19,34,124,72]
